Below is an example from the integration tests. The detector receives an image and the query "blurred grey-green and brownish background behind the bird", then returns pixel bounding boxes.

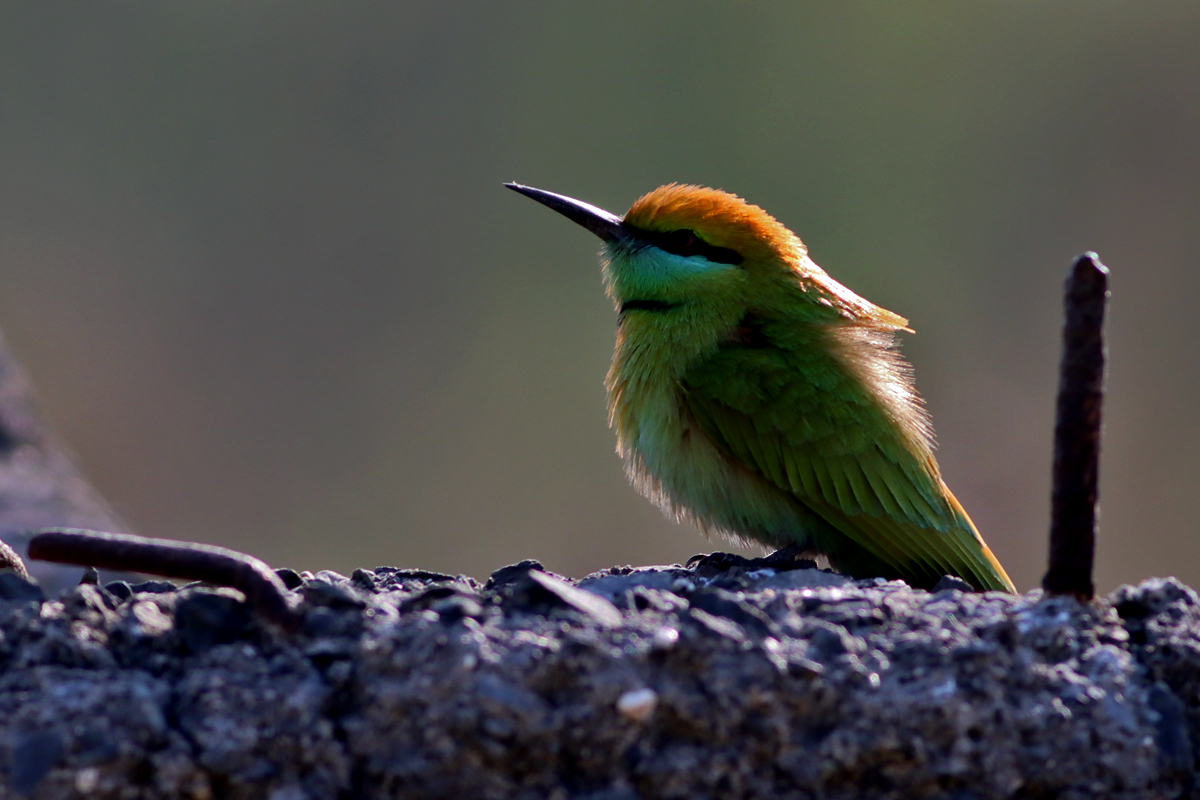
[0,0,1200,590]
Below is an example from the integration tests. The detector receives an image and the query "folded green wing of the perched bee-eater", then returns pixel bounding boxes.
[683,328,1015,591]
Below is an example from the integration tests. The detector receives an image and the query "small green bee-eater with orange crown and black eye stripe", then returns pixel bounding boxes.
[508,184,1015,591]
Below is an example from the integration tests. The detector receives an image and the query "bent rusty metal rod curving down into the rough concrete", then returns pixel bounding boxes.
[29,528,296,630]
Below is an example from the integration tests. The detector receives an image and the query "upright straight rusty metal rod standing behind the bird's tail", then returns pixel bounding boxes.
[1042,253,1109,602]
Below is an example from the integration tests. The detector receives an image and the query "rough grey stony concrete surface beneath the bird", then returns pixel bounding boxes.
[0,557,1200,800]
